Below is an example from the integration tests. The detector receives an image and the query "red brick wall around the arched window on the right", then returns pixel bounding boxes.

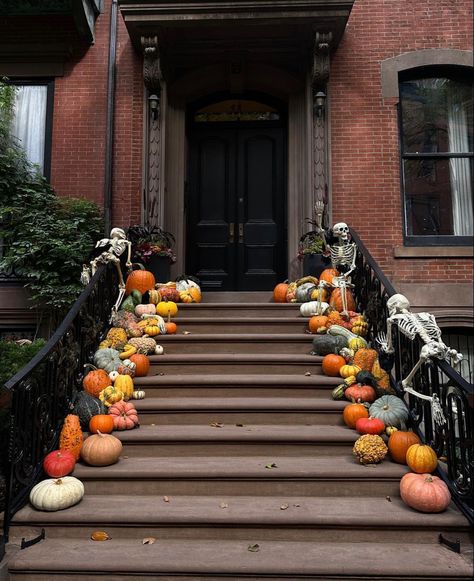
[330,0,473,282]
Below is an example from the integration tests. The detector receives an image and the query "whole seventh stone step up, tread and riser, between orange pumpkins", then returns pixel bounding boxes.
[149,353,322,377]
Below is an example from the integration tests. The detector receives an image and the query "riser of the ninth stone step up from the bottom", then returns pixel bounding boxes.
[171,317,308,334]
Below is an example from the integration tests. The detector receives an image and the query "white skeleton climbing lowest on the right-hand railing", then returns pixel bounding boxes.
[377,294,463,425]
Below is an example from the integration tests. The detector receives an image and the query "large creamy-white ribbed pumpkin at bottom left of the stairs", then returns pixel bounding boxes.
[30,476,84,512]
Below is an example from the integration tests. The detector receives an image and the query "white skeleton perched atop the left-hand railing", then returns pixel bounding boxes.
[81,228,132,315]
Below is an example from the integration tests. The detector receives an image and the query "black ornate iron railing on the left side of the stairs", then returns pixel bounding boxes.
[4,264,118,538]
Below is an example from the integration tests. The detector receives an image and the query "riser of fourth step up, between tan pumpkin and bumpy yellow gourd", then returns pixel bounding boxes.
[119,442,356,461]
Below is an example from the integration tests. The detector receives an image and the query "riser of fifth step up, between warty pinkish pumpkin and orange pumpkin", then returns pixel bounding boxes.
[138,410,343,426]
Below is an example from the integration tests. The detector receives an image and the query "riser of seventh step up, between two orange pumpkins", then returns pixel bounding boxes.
[148,360,322,374]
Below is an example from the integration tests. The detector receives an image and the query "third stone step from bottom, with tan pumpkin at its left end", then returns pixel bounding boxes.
[73,456,408,497]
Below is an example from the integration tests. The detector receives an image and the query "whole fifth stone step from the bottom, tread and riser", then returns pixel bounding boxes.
[133,396,347,426]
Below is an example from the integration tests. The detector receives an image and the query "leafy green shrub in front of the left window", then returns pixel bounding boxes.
[0,78,103,318]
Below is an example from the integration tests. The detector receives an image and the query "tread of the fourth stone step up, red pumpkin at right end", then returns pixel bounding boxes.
[114,424,359,444]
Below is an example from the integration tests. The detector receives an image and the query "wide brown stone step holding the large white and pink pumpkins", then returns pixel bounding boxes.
[11,494,469,544]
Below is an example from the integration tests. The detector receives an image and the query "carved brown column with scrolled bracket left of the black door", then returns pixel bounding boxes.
[141,36,164,226]
